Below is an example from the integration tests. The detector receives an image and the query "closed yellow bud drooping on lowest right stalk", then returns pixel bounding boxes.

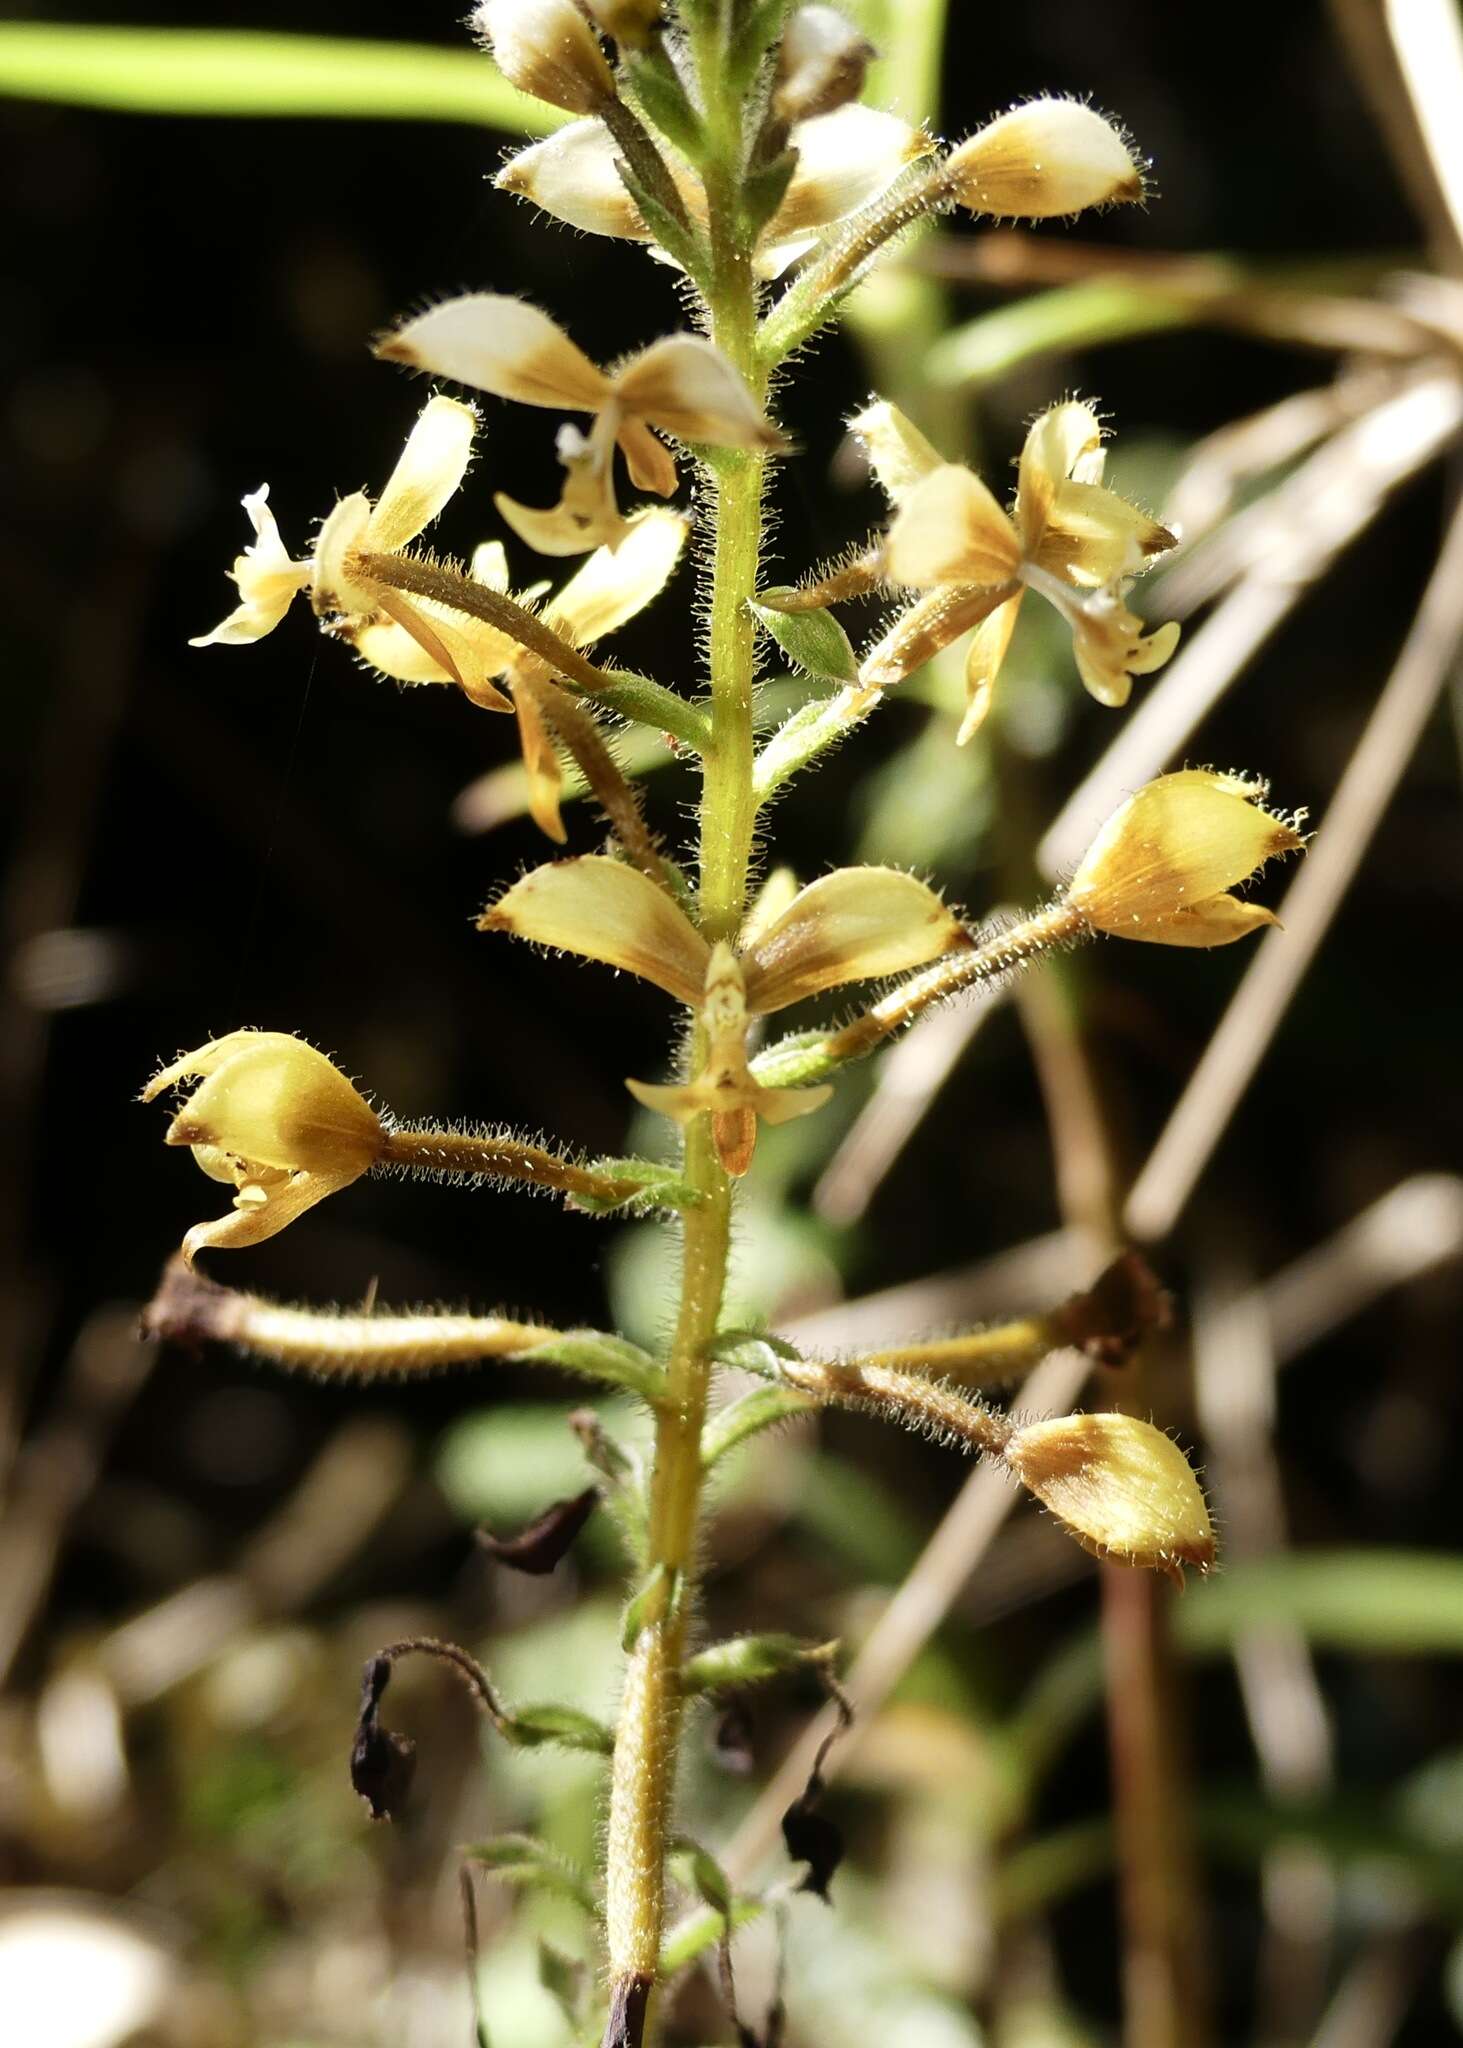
[1004,1415,1215,1585]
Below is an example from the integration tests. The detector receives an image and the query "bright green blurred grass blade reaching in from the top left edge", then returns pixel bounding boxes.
[0,23,563,135]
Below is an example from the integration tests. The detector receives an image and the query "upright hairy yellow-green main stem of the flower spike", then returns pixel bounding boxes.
[604,8,766,2048]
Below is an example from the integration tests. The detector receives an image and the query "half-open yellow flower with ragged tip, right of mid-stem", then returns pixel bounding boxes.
[1068,768,1305,946]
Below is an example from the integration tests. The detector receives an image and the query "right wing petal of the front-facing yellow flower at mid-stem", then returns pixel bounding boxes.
[742,868,967,1016]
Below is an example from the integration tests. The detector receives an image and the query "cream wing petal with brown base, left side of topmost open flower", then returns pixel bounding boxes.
[375,291,611,412]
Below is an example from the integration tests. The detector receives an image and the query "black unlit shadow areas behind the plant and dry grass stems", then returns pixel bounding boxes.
[0,0,1459,2044]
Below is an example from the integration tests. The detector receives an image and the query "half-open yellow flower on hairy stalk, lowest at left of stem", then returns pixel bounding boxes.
[141,1030,385,1266]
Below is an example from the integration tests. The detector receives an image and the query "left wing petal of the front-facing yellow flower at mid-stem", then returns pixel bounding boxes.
[477,854,711,1006]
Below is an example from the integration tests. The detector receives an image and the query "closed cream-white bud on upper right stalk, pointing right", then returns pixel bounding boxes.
[945,98,1143,221]
